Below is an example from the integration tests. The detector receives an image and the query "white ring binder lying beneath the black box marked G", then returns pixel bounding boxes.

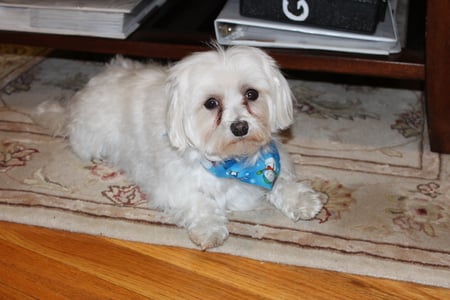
[214,0,401,55]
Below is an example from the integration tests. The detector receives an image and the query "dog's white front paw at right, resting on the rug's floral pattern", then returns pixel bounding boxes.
[273,183,326,221]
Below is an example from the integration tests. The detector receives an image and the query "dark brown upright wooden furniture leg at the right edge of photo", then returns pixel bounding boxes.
[425,0,450,153]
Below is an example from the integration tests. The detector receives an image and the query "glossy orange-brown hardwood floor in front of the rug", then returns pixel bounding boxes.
[0,222,450,300]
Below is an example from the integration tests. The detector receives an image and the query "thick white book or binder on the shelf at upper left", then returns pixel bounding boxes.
[0,0,166,39]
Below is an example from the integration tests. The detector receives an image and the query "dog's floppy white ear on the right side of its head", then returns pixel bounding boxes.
[255,49,294,131]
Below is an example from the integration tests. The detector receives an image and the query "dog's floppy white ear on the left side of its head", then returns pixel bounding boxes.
[166,76,189,151]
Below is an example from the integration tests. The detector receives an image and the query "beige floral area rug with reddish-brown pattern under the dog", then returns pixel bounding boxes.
[0,45,450,287]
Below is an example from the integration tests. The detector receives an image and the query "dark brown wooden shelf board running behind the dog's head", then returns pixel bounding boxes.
[0,31,425,80]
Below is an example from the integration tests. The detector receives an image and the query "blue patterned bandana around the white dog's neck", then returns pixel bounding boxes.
[203,142,281,190]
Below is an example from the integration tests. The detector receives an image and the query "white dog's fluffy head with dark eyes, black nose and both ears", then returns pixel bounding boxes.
[167,47,293,160]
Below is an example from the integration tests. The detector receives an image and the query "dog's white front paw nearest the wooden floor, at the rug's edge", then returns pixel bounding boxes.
[188,224,228,250]
